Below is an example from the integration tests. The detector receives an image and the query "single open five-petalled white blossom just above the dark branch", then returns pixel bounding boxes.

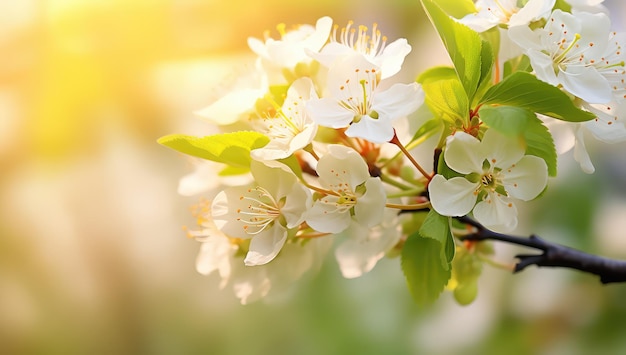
[428,129,548,231]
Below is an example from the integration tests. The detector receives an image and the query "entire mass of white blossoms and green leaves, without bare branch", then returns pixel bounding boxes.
[159,0,626,304]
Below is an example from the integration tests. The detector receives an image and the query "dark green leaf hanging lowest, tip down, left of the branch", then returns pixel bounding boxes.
[401,233,451,306]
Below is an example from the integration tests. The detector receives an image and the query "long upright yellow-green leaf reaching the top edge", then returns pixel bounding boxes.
[422,0,493,102]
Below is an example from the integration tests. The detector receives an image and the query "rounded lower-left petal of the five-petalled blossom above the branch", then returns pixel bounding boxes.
[428,175,478,216]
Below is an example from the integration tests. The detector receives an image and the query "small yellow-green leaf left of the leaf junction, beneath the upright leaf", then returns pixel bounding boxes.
[422,78,469,126]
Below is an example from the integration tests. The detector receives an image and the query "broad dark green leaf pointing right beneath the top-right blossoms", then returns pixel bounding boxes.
[481,72,595,122]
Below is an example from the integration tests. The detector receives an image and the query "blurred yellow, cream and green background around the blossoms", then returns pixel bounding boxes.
[0,0,626,354]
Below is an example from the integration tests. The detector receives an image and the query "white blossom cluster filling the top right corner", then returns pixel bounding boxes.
[460,0,626,173]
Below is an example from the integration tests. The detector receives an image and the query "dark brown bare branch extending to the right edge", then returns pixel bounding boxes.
[456,216,626,284]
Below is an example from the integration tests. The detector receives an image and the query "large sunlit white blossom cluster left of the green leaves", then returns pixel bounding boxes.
[179,17,424,303]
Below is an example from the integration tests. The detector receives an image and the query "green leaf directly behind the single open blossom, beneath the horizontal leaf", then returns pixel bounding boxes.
[478,106,557,176]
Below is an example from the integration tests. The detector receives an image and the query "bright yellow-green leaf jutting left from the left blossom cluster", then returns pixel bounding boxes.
[157,131,269,173]
